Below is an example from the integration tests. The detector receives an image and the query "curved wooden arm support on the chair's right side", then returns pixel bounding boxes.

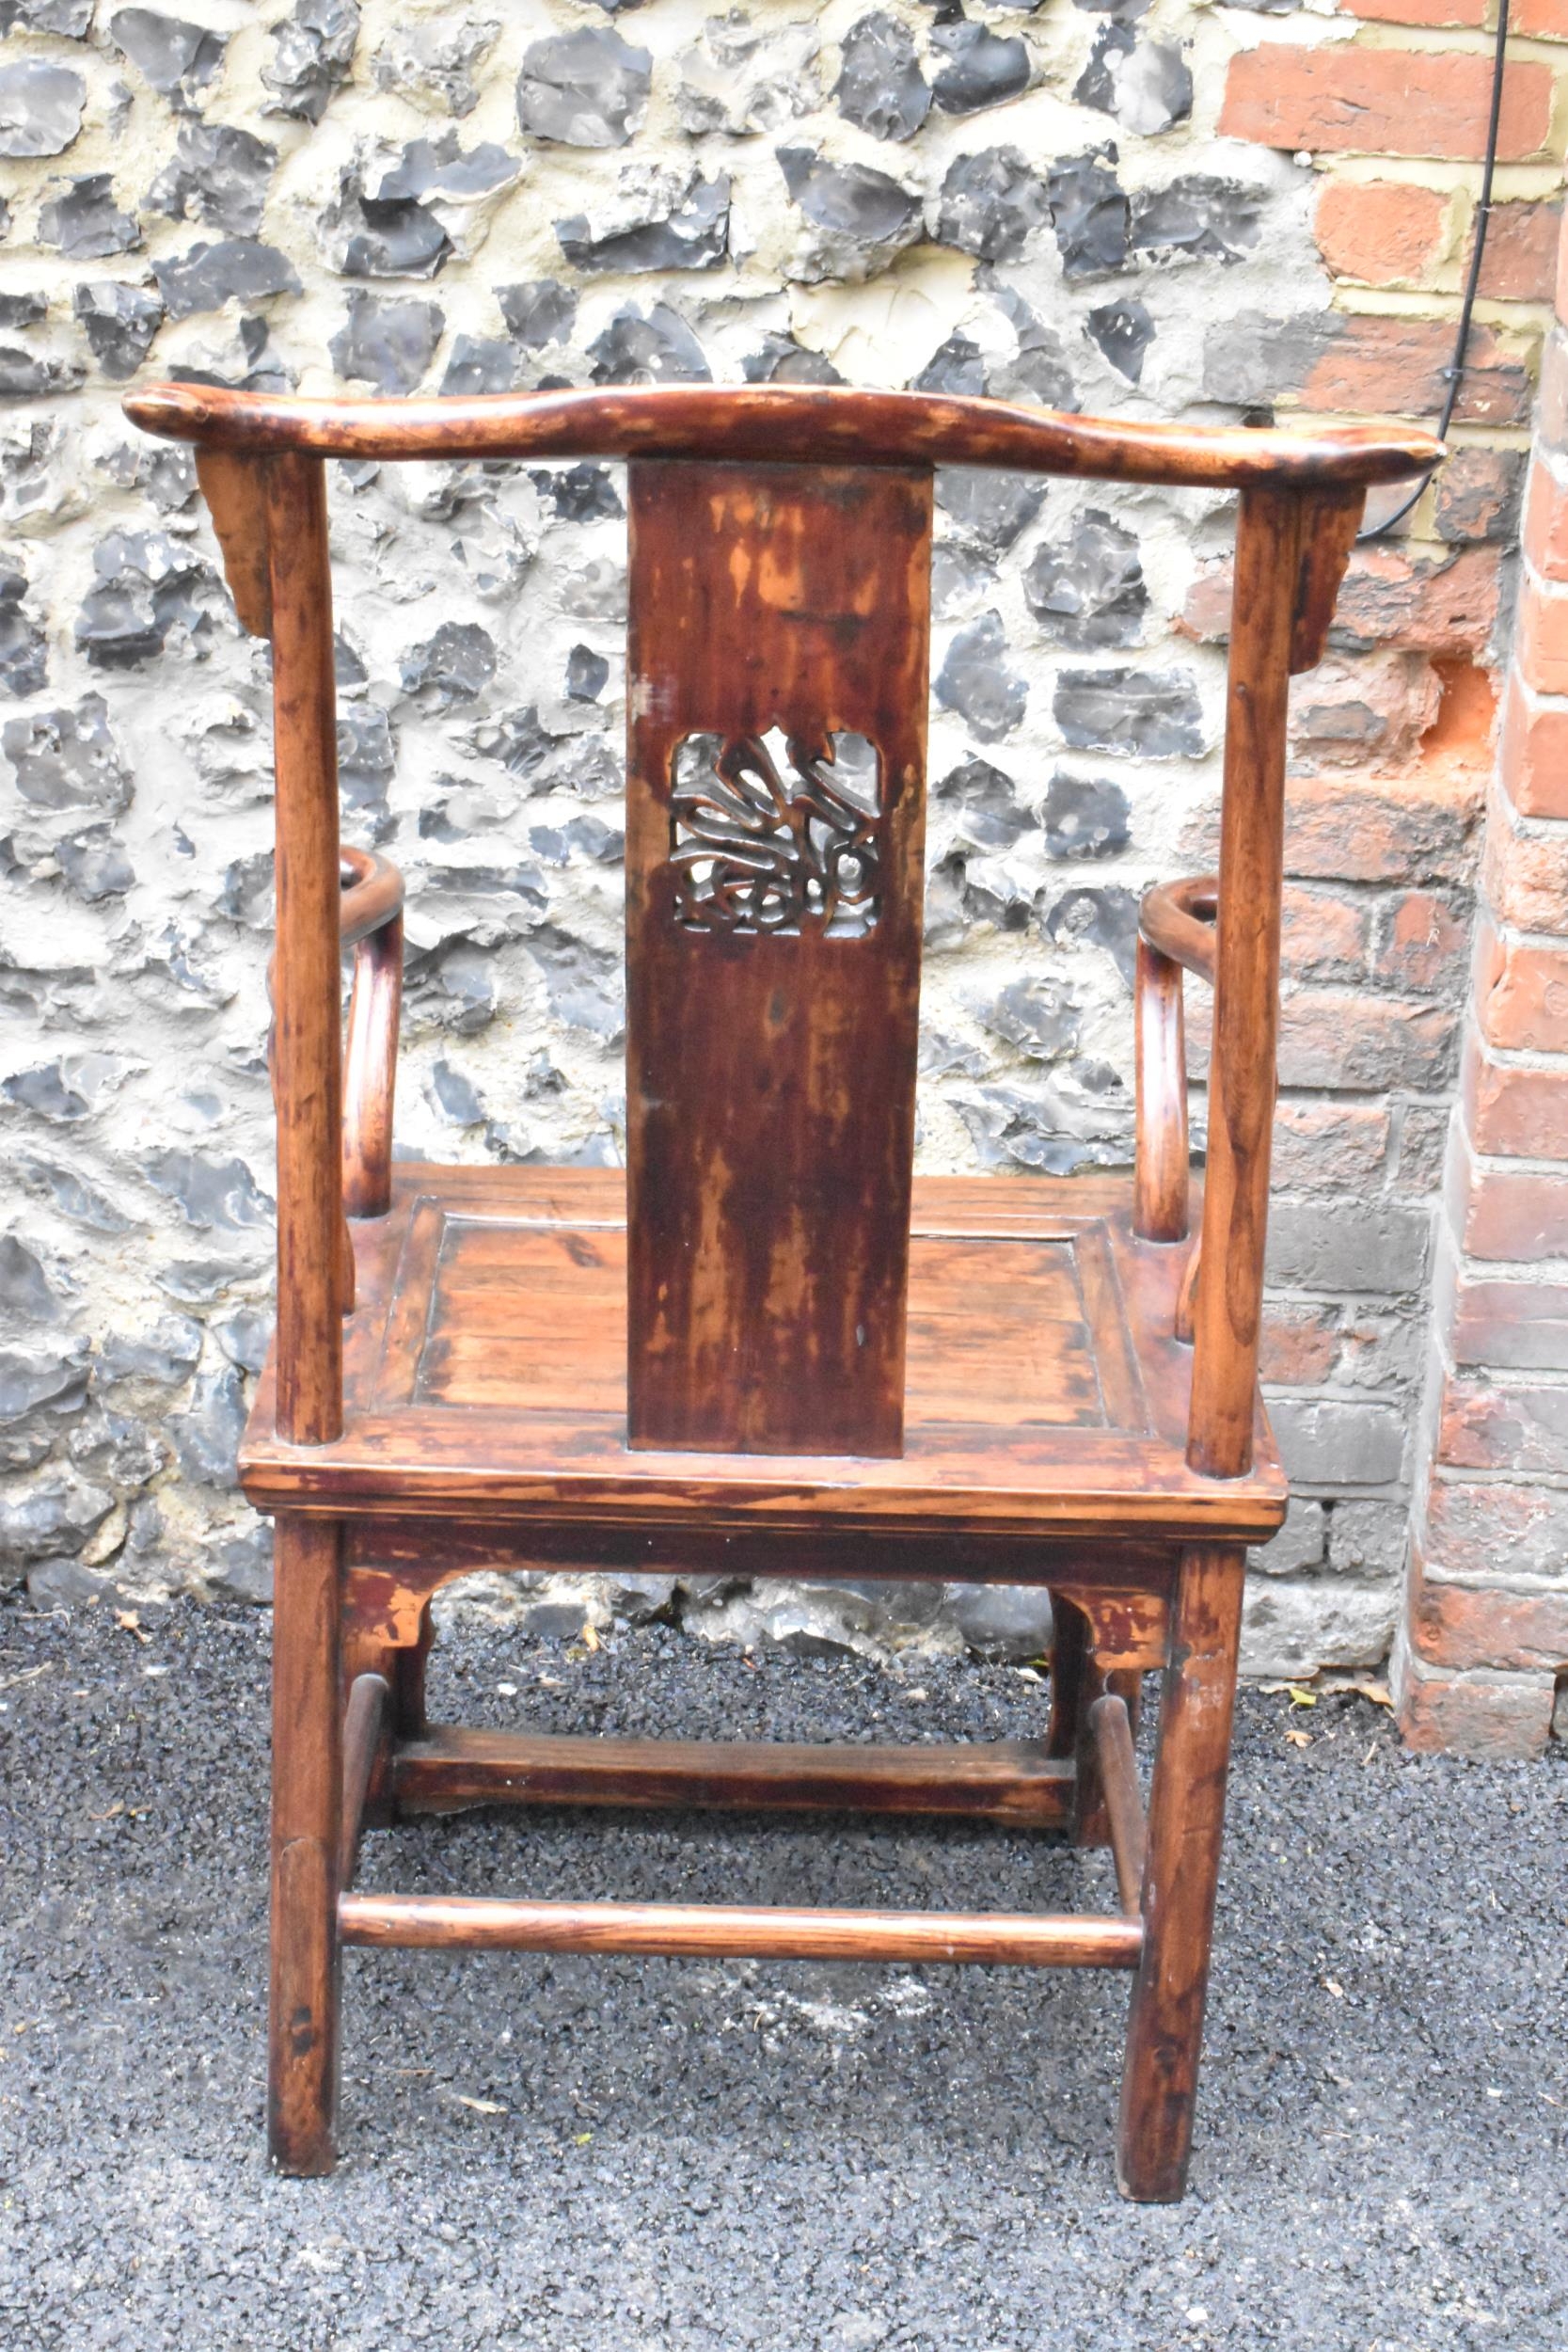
[1133,875,1220,1242]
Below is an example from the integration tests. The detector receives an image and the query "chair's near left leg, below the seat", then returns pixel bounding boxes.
[268,1518,343,2173]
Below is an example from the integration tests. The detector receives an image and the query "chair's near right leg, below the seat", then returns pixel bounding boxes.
[1117,1546,1246,2204]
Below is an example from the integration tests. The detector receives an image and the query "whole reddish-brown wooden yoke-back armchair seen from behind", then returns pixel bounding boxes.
[127,386,1439,2200]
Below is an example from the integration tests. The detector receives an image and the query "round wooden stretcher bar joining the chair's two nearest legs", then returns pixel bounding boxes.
[339,1896,1143,1969]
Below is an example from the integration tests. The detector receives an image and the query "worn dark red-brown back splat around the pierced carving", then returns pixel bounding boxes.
[626,461,931,1454]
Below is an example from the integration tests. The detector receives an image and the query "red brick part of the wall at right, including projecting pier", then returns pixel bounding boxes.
[1222,0,1568,1712]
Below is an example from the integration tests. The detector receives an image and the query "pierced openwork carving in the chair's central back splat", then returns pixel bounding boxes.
[670,727,881,939]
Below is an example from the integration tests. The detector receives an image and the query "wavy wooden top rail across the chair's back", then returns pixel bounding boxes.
[124,384,1444,489]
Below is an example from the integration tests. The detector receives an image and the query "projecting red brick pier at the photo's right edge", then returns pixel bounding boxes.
[1397,198,1568,1755]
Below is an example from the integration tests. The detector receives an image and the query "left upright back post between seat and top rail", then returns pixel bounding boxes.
[265,452,343,1444]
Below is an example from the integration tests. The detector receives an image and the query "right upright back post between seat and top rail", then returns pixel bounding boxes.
[1187,489,1312,1477]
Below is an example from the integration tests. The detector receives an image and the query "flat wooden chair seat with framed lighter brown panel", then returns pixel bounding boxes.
[242,1165,1284,1541]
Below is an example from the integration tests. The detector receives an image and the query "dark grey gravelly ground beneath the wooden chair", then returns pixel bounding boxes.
[0,1604,1568,2352]
